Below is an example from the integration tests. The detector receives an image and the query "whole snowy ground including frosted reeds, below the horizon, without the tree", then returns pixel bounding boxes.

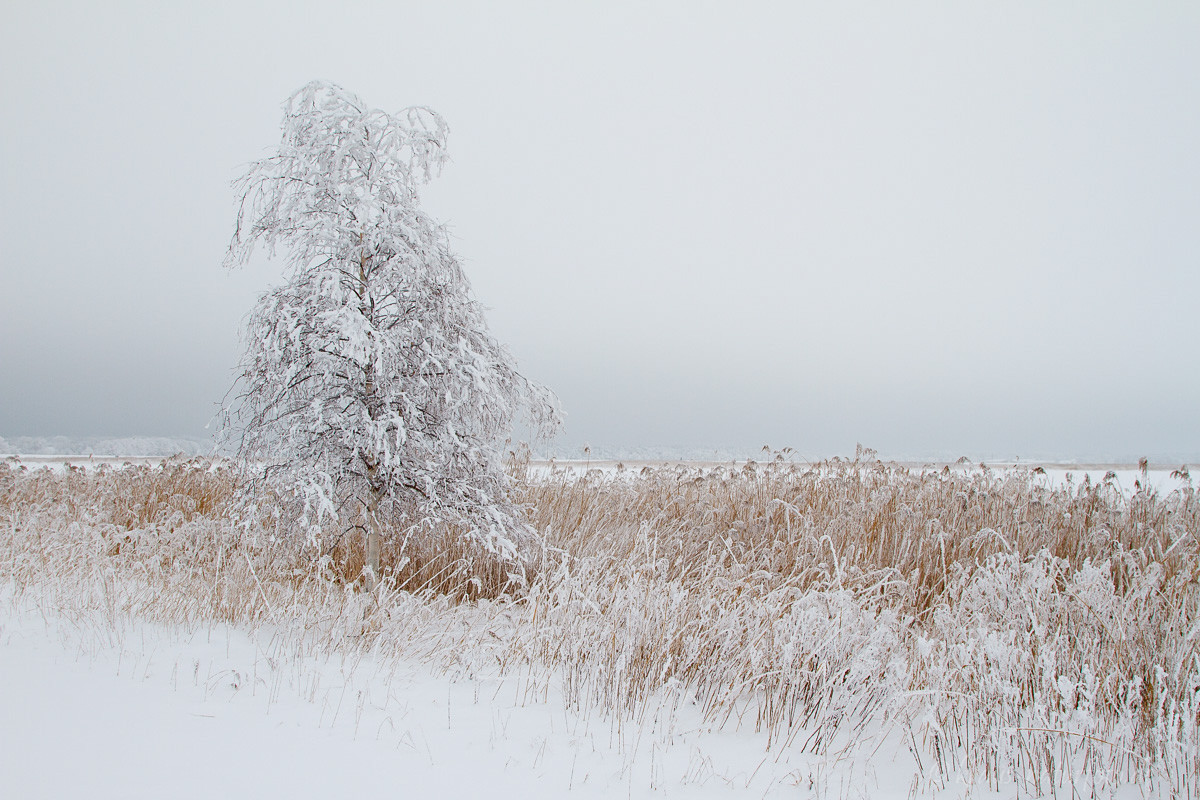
[0,452,1200,798]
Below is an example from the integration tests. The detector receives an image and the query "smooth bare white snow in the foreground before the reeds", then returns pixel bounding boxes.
[0,596,945,800]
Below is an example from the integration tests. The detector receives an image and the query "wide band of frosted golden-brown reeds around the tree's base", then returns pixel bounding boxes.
[0,458,1200,796]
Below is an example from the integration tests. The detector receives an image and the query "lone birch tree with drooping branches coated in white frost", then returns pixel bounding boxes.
[224,82,559,583]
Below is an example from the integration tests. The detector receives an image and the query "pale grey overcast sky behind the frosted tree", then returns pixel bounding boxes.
[0,0,1200,458]
